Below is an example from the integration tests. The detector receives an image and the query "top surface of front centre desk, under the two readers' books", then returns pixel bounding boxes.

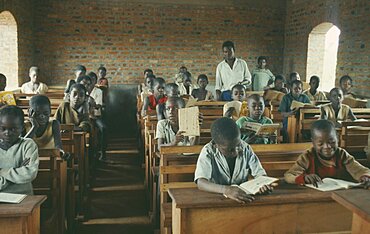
[169,183,333,208]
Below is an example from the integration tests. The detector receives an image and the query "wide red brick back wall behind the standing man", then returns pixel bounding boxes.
[34,0,285,85]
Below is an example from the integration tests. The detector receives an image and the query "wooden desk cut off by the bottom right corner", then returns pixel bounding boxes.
[332,189,370,234]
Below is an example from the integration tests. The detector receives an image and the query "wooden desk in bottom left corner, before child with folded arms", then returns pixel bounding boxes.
[0,196,46,234]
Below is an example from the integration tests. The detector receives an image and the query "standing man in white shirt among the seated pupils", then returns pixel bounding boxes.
[215,41,251,101]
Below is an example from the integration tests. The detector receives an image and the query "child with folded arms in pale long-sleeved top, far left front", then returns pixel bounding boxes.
[0,106,39,195]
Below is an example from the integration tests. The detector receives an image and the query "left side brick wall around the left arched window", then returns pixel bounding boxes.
[0,0,34,87]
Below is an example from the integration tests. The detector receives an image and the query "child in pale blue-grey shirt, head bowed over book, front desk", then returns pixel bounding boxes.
[194,117,272,203]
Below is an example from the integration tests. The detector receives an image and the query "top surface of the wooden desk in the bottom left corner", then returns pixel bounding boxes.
[0,196,46,218]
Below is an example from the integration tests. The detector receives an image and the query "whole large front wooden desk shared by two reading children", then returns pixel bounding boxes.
[169,184,352,234]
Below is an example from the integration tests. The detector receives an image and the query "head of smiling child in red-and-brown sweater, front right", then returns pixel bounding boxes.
[311,119,338,159]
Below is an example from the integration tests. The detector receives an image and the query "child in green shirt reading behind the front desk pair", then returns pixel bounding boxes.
[236,94,276,144]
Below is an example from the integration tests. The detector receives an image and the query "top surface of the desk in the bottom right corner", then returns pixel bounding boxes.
[332,189,370,222]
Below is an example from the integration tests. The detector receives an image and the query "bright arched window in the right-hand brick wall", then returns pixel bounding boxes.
[306,23,340,91]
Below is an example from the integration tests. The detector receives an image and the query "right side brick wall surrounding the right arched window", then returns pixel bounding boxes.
[284,0,370,97]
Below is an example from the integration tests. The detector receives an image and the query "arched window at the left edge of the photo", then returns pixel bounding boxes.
[0,11,18,90]
